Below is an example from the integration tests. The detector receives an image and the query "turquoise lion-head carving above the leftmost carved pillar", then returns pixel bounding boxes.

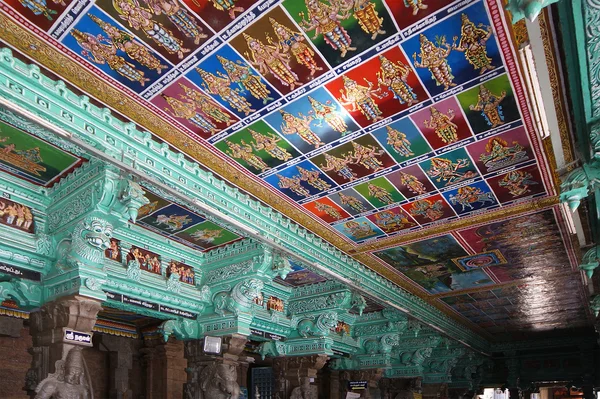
[56,216,113,273]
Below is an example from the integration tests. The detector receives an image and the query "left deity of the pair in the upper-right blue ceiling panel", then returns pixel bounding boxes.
[413,34,456,90]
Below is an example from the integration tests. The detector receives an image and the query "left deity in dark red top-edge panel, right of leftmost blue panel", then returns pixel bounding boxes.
[113,0,190,59]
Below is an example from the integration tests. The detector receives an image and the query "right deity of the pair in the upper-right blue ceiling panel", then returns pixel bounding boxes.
[452,14,496,75]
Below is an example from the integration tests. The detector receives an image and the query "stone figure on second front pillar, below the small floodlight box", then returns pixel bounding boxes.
[200,363,240,399]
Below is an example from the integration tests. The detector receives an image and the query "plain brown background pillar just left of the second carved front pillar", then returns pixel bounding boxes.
[140,338,187,399]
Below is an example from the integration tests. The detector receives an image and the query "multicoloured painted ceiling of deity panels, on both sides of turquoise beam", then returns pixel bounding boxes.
[0,0,587,336]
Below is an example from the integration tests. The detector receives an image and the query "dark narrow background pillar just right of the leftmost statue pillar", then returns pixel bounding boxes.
[98,334,135,399]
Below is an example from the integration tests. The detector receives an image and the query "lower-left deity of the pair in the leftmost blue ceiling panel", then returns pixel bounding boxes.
[71,29,149,86]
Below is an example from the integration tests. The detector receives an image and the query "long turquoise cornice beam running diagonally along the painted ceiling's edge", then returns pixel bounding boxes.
[0,48,488,350]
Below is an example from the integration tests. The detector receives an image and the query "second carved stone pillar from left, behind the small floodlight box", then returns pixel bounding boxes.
[184,334,248,399]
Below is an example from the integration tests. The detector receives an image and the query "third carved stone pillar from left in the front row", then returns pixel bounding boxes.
[273,355,329,398]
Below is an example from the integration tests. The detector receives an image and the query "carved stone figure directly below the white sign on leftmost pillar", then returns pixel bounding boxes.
[35,346,93,399]
